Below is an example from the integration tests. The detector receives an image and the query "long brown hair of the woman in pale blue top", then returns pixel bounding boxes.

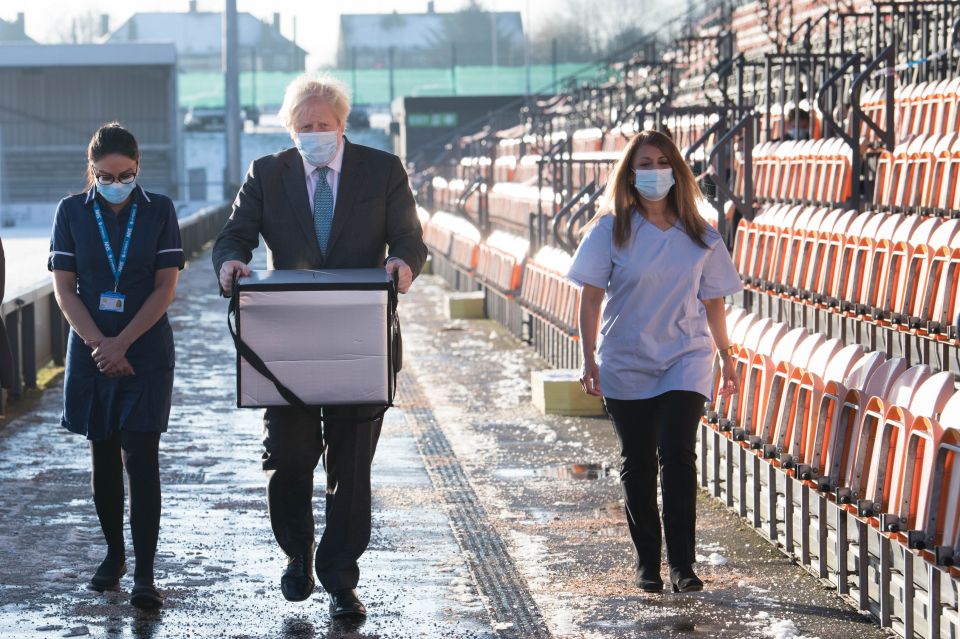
[584,130,707,248]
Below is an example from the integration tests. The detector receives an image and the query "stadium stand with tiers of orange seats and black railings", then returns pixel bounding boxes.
[414,0,960,639]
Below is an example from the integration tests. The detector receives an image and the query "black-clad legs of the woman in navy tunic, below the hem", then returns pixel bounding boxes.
[90,431,160,583]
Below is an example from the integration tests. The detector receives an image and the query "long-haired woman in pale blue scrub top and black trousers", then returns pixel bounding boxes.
[567,131,741,592]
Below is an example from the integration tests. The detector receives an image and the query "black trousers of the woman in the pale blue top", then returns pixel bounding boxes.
[604,391,706,575]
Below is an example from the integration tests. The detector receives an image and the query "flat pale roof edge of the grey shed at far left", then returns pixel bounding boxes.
[0,43,177,68]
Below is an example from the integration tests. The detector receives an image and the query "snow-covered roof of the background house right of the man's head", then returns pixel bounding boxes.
[340,11,523,49]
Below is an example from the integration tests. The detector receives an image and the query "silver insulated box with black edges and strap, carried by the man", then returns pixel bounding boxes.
[231,268,402,408]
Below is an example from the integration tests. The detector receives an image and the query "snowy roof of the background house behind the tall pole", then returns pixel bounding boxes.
[107,11,303,56]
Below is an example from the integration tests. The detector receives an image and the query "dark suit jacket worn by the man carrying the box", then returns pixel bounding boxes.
[213,138,427,277]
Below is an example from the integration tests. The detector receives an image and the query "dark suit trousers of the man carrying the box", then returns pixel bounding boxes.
[263,406,383,592]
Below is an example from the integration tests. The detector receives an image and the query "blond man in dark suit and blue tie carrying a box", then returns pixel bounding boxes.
[213,76,427,619]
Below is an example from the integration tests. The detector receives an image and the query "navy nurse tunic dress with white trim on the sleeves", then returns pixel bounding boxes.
[47,185,184,440]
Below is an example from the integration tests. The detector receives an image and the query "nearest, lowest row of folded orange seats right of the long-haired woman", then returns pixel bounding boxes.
[706,309,960,566]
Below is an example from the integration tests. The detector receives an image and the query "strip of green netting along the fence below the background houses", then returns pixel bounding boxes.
[179,63,596,107]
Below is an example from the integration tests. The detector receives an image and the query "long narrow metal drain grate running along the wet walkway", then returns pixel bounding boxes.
[397,374,550,639]
